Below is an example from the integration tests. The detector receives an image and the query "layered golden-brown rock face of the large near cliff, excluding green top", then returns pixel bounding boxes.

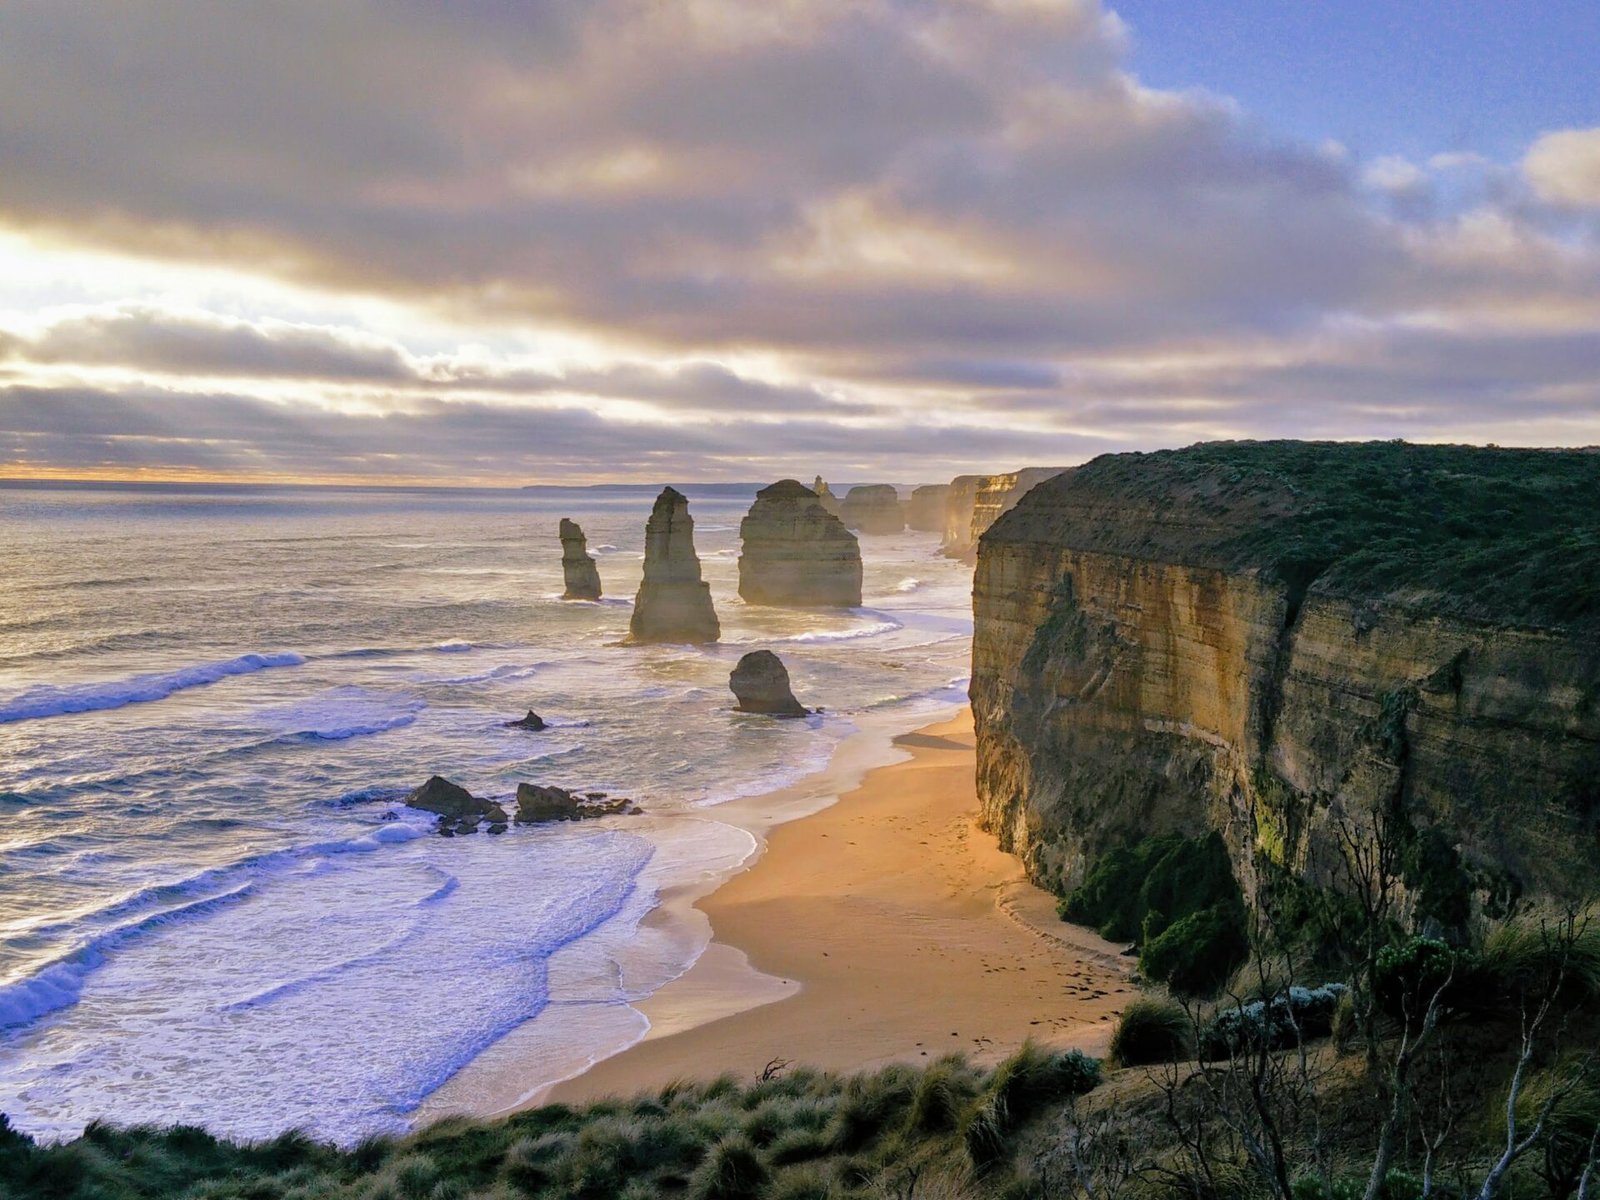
[971,446,1600,920]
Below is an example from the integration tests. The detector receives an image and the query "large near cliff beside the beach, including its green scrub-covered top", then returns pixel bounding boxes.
[971,443,1600,925]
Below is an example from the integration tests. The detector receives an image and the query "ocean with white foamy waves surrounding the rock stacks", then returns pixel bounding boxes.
[0,486,971,1144]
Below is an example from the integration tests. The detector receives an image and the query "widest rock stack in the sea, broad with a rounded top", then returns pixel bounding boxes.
[739,478,861,608]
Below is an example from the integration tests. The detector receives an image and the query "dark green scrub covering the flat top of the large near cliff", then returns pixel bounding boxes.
[997,442,1600,627]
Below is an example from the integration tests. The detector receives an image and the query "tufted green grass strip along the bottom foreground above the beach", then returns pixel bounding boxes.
[0,1046,1099,1200]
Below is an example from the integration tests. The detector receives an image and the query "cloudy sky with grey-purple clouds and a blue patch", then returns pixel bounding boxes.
[0,0,1600,483]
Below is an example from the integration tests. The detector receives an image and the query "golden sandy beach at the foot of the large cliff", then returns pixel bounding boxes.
[544,712,1133,1102]
